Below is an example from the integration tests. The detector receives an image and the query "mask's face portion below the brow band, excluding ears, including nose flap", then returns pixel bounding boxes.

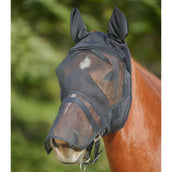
[45,50,131,153]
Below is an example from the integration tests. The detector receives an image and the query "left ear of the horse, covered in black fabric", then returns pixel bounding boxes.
[70,8,88,43]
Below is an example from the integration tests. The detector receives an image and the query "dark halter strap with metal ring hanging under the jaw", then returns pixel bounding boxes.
[80,136,103,172]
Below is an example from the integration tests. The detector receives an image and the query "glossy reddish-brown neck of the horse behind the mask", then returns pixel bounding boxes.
[104,59,161,172]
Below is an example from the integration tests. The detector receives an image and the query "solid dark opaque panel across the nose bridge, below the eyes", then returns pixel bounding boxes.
[61,68,111,125]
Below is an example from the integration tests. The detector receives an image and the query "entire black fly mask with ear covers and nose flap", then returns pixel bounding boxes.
[45,8,132,165]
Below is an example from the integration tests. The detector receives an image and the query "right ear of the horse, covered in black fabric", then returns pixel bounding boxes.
[107,7,128,43]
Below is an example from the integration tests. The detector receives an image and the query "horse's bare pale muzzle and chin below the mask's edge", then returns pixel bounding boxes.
[50,139,86,164]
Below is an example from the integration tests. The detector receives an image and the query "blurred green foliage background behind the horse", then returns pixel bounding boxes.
[11,0,161,172]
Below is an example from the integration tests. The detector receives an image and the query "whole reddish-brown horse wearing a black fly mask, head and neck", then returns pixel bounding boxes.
[45,7,161,172]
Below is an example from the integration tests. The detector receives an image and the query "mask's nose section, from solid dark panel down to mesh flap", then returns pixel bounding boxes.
[46,68,111,152]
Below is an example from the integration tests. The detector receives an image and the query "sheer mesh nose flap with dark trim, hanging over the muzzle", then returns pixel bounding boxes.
[45,92,111,154]
